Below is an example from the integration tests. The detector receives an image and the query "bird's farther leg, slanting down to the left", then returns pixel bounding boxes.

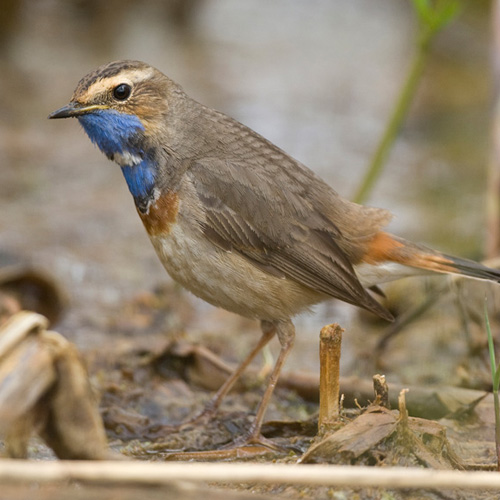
[183,321,279,425]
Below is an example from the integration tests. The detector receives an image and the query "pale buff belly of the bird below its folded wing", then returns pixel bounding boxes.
[146,224,328,320]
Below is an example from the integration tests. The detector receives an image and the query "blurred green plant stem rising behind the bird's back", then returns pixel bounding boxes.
[354,0,459,203]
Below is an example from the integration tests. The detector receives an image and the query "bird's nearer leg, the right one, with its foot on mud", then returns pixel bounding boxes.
[228,320,295,449]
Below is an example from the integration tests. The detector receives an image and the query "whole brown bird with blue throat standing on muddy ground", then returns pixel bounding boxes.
[49,61,500,450]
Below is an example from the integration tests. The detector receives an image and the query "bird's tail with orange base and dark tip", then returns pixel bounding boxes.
[356,231,500,284]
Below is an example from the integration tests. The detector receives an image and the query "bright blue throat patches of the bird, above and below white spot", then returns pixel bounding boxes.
[78,109,156,204]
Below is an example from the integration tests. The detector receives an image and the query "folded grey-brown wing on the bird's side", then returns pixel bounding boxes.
[189,159,390,319]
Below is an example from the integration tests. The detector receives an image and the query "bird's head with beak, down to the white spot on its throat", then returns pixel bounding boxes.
[49,61,177,166]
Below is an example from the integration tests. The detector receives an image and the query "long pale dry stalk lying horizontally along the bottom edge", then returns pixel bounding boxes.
[0,460,500,491]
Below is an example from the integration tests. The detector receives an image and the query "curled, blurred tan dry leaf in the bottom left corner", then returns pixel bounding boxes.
[0,311,111,459]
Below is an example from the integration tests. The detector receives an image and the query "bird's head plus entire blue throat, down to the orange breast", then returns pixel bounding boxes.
[49,61,185,211]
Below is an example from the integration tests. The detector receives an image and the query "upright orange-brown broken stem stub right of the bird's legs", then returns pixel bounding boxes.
[318,323,344,431]
